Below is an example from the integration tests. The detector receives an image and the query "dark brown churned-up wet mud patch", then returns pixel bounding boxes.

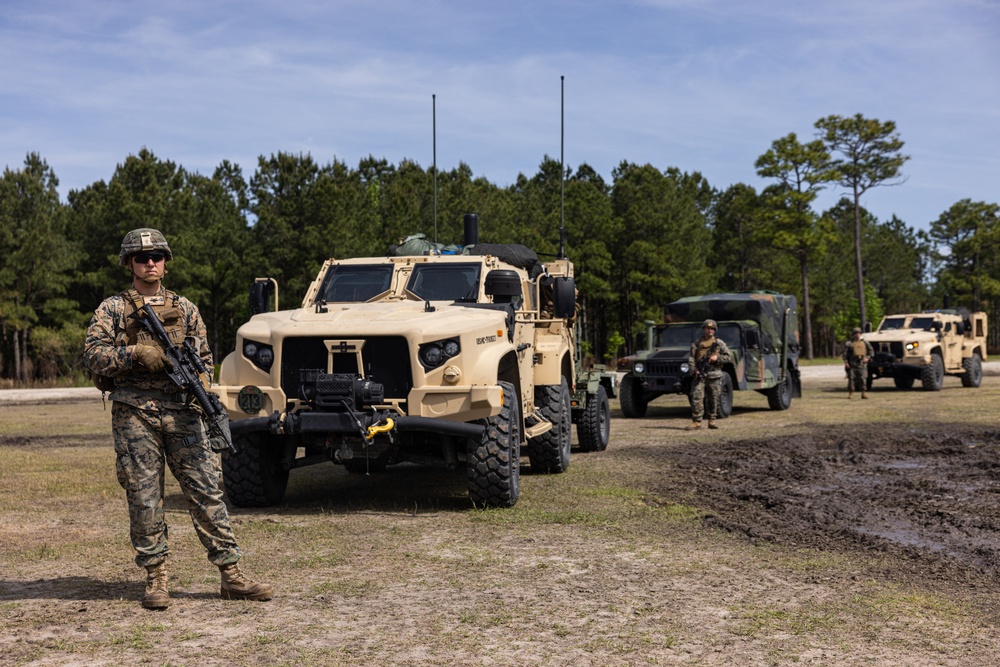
[644,426,1000,586]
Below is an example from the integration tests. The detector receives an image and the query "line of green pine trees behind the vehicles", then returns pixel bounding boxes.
[0,114,1000,385]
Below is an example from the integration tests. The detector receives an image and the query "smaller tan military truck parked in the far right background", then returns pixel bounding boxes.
[861,309,987,391]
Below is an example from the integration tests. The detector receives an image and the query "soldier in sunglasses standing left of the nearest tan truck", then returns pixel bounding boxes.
[83,229,272,609]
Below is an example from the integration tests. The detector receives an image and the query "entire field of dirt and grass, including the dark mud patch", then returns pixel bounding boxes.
[0,368,1000,666]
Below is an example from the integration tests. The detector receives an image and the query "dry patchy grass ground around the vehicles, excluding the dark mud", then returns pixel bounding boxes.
[0,378,1000,665]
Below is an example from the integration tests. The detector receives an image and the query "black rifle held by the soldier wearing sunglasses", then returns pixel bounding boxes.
[135,304,236,454]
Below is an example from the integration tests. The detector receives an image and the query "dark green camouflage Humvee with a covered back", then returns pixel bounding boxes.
[619,292,802,417]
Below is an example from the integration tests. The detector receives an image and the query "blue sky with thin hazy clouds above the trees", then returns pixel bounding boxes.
[0,0,1000,228]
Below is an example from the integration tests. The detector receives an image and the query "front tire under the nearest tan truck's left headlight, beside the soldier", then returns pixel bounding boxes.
[222,433,288,507]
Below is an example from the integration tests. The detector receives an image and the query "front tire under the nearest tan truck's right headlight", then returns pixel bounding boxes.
[466,382,521,507]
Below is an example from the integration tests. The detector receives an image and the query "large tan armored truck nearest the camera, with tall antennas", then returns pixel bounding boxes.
[214,220,607,507]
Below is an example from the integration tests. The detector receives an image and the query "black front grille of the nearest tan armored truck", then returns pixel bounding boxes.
[281,336,413,401]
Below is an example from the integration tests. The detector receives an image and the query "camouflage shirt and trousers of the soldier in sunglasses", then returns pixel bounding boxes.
[83,287,240,567]
